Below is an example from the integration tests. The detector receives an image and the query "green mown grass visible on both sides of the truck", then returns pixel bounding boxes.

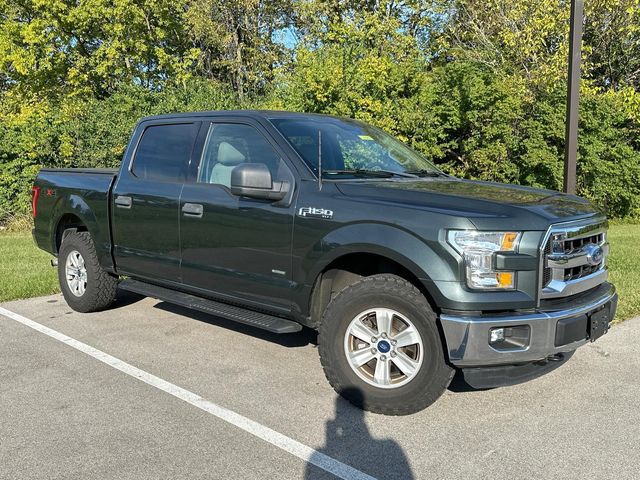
[0,223,640,322]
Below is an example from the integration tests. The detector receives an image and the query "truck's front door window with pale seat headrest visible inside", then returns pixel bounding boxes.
[198,123,287,188]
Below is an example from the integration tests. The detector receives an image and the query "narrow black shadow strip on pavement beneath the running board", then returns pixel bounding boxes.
[153,301,318,348]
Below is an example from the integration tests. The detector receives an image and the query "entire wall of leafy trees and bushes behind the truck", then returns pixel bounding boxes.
[0,0,640,222]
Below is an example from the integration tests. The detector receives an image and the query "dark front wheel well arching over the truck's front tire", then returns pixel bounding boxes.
[309,253,436,326]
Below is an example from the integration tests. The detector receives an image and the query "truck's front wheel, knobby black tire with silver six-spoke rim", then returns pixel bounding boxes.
[318,274,455,415]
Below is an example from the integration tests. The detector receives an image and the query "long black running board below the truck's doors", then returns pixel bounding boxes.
[118,278,302,333]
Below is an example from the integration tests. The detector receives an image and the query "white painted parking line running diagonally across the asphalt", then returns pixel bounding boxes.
[0,307,375,480]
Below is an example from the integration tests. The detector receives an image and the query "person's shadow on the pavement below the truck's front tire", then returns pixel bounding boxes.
[304,388,415,480]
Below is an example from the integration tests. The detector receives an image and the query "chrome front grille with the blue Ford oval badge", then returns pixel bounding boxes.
[540,221,609,298]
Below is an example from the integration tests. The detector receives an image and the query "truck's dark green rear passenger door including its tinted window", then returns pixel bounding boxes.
[111,121,200,283]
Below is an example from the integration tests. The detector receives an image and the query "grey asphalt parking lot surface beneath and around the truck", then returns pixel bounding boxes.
[0,293,640,479]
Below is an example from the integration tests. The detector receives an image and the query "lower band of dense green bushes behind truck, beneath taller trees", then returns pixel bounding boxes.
[0,67,640,223]
